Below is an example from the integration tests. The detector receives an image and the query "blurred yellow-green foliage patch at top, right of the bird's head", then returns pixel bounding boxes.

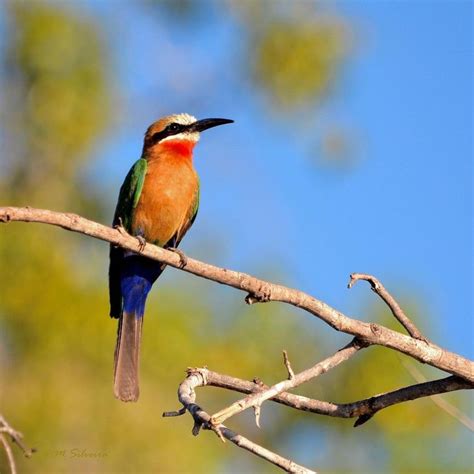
[223,0,349,112]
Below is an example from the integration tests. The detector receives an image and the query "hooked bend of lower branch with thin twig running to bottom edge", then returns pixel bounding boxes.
[168,369,315,474]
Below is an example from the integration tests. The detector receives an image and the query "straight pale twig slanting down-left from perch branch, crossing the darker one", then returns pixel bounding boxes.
[211,339,366,425]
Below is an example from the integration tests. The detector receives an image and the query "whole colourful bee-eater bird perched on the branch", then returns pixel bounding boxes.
[109,113,233,402]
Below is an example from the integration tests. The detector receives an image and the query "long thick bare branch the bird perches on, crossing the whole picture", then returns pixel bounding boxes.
[0,207,474,383]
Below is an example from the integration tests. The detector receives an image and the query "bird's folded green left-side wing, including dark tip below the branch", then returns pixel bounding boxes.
[109,158,147,318]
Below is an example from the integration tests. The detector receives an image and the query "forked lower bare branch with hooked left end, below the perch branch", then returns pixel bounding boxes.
[163,358,473,472]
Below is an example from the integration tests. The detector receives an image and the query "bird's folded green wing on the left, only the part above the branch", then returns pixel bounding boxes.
[114,158,147,232]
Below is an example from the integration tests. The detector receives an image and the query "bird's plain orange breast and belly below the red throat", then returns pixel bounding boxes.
[132,153,199,246]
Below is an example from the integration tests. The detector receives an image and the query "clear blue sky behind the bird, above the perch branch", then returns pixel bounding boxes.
[82,1,474,357]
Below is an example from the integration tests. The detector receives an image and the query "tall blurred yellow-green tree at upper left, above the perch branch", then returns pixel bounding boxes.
[1,2,109,208]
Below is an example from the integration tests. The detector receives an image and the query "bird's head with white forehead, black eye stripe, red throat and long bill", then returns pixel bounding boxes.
[143,114,233,156]
